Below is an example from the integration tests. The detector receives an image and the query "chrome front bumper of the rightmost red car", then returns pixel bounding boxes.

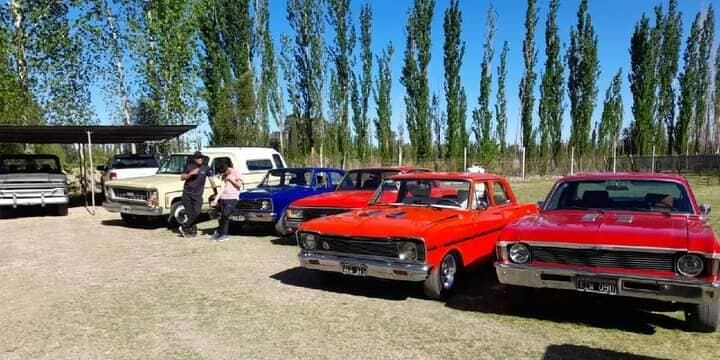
[495,263,720,304]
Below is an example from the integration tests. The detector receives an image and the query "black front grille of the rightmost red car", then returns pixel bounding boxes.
[530,246,675,271]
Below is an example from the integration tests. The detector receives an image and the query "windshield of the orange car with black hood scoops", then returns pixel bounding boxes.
[373,179,470,209]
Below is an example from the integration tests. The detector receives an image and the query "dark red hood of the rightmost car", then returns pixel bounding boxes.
[502,210,688,249]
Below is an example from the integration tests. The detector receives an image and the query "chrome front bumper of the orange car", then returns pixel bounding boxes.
[298,250,430,281]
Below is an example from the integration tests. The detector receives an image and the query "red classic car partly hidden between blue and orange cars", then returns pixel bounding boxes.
[283,166,430,234]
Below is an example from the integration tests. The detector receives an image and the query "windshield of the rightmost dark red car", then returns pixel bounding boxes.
[545,180,692,213]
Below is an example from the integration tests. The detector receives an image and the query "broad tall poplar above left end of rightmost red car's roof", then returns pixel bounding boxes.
[566,0,600,156]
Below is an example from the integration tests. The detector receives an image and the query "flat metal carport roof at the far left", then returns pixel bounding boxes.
[0,125,196,144]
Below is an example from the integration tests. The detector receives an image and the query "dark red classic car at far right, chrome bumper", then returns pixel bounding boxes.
[495,173,720,331]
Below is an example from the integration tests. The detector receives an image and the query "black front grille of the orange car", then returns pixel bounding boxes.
[317,236,425,261]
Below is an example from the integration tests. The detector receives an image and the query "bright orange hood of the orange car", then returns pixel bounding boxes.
[300,206,468,239]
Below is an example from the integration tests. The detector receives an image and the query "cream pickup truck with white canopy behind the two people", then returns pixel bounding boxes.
[103,147,287,225]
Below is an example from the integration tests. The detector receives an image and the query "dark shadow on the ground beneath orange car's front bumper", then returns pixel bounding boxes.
[270,267,422,301]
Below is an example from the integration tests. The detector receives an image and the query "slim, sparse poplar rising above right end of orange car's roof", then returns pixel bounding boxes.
[473,5,495,161]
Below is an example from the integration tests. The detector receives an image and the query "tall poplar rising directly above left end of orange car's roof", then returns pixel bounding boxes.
[400,0,435,159]
